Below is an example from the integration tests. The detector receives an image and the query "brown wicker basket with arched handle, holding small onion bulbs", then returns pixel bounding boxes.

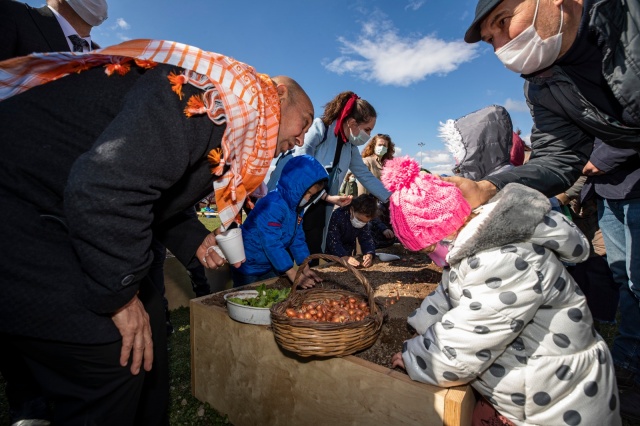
[271,254,384,357]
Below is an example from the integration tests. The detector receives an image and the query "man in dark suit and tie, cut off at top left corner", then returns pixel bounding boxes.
[0,0,107,61]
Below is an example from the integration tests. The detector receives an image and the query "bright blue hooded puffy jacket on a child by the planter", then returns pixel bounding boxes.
[239,155,329,275]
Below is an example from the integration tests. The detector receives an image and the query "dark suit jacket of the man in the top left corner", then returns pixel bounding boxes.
[0,0,99,61]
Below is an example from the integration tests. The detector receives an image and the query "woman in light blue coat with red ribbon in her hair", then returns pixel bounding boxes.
[269,92,391,264]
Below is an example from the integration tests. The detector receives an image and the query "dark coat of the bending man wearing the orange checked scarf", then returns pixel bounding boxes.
[0,65,225,344]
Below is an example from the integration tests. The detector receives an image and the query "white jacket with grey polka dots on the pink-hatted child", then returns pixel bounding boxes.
[402,183,621,425]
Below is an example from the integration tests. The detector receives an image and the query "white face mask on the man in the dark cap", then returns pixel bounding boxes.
[496,0,564,74]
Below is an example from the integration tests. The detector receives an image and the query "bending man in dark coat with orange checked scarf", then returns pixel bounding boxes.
[0,45,313,425]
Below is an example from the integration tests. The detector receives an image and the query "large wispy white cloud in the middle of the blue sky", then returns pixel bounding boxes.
[324,20,477,86]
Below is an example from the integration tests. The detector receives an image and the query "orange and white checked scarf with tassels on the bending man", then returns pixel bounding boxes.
[0,39,280,228]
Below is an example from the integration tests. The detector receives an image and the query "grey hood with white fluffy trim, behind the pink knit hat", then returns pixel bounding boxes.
[440,105,513,181]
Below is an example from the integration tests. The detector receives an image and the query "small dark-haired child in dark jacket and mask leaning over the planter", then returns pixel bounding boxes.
[326,194,378,268]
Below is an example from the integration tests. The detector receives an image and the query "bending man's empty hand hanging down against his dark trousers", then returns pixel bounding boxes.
[111,296,153,375]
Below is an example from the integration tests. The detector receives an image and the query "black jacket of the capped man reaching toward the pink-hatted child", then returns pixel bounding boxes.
[487,0,640,197]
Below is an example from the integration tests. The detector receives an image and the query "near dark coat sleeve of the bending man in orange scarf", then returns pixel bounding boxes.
[64,67,213,314]
